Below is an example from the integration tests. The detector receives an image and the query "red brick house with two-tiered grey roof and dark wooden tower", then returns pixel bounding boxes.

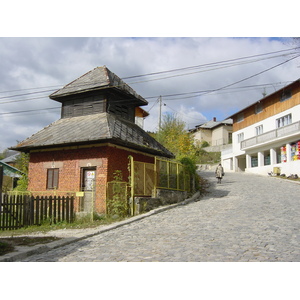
[13,66,174,213]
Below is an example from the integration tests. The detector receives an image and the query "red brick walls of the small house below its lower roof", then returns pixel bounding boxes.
[28,146,154,213]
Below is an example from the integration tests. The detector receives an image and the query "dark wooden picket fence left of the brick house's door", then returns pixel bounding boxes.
[0,194,74,230]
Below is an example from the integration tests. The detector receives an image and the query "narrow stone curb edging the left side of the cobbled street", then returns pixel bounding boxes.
[0,191,200,262]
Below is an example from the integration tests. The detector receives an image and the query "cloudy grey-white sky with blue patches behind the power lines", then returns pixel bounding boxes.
[0,37,300,150]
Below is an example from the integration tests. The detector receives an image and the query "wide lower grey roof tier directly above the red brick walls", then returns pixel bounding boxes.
[11,113,174,158]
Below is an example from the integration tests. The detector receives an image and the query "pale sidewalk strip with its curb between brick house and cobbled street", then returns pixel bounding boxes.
[0,192,200,262]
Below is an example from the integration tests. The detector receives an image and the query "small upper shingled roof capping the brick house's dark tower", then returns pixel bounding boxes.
[49,66,148,106]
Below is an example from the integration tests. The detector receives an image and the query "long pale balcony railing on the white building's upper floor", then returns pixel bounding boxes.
[241,122,300,150]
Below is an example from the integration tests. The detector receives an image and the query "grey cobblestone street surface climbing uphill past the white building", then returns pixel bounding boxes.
[5,171,300,262]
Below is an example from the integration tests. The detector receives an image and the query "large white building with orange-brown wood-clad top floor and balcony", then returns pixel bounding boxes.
[221,79,300,176]
